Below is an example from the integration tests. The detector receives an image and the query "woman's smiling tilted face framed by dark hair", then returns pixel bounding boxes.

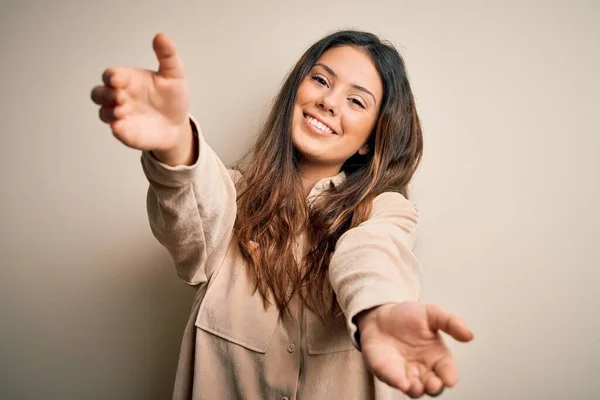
[292,46,383,173]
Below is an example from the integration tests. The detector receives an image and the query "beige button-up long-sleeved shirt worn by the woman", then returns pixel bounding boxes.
[141,118,420,400]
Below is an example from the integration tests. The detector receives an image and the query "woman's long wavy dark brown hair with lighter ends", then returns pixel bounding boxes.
[234,30,423,319]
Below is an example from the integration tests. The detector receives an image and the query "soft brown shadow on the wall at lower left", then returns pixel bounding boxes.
[0,241,195,400]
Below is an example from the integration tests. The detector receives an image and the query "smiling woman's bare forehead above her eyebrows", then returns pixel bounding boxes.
[317,46,382,98]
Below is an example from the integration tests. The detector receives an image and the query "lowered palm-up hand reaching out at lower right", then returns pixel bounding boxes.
[357,302,473,398]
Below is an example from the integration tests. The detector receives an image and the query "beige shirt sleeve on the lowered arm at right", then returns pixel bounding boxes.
[329,192,421,350]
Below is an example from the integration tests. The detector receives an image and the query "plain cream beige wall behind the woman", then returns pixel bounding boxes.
[0,0,600,400]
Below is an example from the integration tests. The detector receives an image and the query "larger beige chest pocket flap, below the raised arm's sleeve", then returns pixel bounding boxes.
[195,244,279,353]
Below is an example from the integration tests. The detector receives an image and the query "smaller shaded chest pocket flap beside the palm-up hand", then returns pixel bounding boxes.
[304,302,356,355]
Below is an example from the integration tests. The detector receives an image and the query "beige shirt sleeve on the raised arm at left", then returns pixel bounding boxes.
[141,116,237,285]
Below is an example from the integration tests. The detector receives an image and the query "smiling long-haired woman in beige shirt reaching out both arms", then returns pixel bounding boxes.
[92,31,473,399]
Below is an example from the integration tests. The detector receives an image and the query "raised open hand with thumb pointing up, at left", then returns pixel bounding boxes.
[91,33,191,158]
